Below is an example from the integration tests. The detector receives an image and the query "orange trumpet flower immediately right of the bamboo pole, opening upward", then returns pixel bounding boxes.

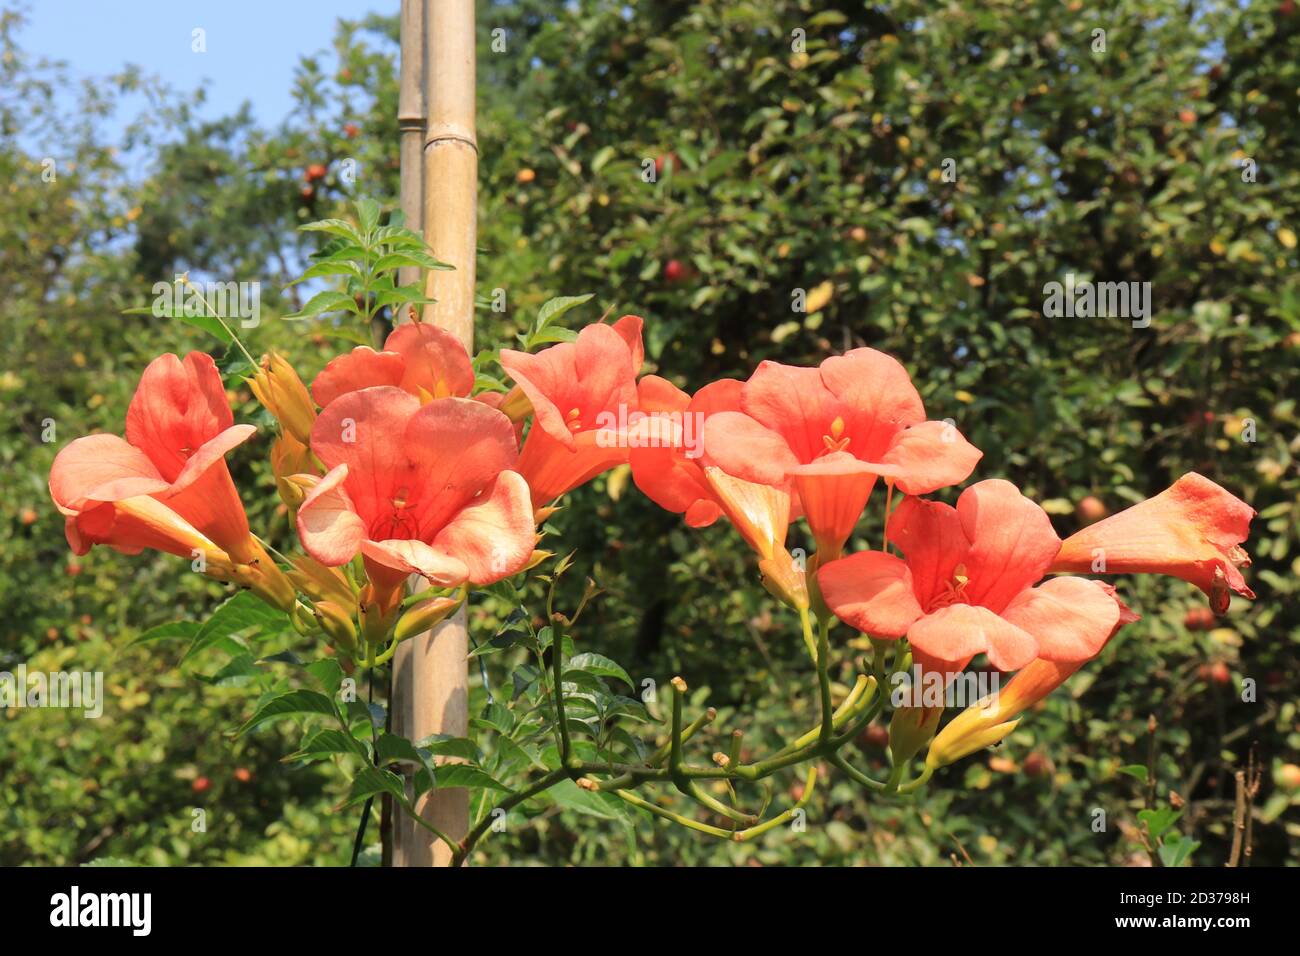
[501,315,645,509]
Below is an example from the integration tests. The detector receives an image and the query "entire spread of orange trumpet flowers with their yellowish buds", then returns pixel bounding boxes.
[49,315,1255,766]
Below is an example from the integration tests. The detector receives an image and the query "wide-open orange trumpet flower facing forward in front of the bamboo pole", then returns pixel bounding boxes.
[298,386,536,610]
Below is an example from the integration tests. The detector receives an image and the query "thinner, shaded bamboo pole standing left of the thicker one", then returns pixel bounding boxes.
[389,0,430,866]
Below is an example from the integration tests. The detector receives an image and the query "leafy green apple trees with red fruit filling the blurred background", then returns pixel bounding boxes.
[0,0,1300,865]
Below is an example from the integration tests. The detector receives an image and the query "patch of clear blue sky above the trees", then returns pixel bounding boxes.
[16,0,379,125]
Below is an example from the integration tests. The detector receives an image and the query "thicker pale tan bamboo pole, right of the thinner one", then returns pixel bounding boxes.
[394,0,478,866]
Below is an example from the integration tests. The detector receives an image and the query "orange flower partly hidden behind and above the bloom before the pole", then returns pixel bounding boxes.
[312,323,475,408]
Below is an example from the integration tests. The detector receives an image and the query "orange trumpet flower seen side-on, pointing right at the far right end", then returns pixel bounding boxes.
[1050,471,1255,614]
